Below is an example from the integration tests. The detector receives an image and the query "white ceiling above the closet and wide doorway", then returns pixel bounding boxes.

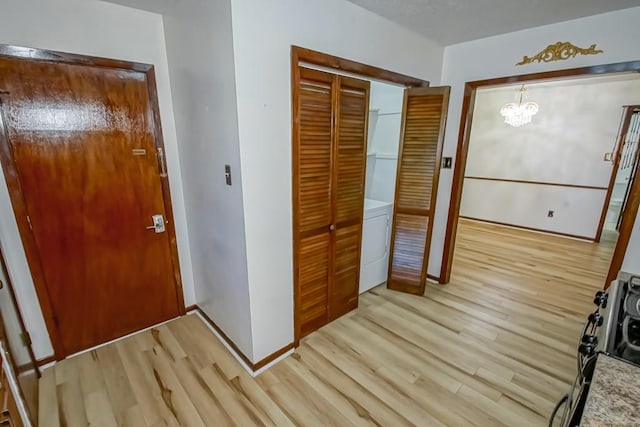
[349,0,640,46]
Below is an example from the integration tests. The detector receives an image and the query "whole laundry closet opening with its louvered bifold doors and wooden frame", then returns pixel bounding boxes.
[292,46,449,345]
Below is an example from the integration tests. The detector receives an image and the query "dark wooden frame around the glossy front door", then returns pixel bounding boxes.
[0,44,185,360]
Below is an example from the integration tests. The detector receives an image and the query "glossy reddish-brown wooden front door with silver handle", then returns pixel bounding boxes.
[0,49,184,359]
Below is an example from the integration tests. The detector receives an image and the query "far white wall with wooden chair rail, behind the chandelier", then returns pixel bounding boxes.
[460,74,640,238]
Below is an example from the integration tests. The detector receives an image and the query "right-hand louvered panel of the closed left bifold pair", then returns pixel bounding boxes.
[329,77,370,320]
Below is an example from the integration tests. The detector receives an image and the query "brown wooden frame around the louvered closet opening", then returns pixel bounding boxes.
[291,46,429,347]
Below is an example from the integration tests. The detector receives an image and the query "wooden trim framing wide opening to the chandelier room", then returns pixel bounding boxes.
[439,61,640,286]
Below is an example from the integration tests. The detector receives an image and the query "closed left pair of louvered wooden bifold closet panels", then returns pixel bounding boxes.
[293,67,370,340]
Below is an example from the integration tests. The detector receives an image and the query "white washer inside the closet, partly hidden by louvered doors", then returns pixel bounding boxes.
[360,199,393,293]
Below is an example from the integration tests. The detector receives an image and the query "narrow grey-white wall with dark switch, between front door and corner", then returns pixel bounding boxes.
[164,0,253,356]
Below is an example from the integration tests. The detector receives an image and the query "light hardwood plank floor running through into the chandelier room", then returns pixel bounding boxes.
[40,220,613,427]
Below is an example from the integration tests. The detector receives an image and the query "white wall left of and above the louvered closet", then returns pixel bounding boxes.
[231,0,442,360]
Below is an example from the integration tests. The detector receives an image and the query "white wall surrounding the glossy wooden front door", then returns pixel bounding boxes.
[0,0,195,358]
